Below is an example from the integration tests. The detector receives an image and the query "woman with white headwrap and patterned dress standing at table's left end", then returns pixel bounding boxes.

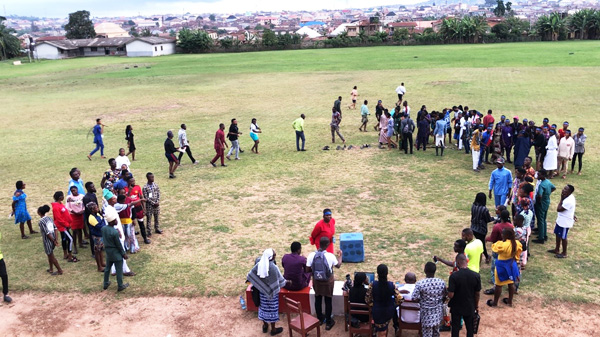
[247,248,288,336]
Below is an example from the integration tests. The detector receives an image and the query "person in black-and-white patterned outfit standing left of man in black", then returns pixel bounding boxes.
[413,262,446,337]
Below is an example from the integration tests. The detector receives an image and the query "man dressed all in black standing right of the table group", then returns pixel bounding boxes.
[448,254,481,337]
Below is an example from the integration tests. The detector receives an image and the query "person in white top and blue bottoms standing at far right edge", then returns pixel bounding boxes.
[548,184,577,259]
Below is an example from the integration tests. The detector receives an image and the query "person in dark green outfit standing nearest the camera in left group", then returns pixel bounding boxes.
[101,203,129,291]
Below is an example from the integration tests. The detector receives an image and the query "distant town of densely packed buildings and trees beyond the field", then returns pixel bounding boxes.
[3,0,600,59]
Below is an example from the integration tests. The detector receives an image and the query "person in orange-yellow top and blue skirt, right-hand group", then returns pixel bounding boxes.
[486,228,523,307]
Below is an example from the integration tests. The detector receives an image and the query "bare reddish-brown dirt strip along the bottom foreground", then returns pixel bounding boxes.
[0,291,600,337]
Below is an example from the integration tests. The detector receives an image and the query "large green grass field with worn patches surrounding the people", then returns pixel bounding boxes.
[0,41,600,303]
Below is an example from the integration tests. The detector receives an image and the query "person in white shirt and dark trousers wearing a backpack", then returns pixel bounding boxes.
[306,236,342,331]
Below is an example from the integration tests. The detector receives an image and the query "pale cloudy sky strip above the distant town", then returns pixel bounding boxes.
[0,0,424,17]
